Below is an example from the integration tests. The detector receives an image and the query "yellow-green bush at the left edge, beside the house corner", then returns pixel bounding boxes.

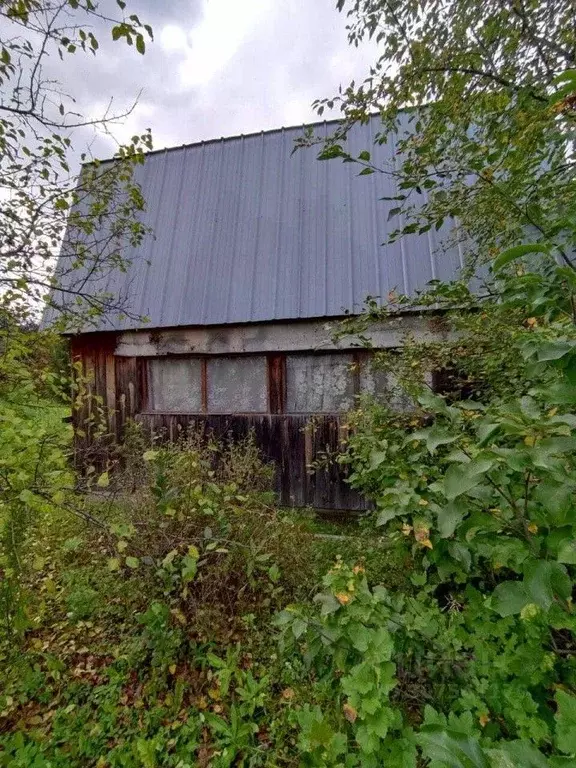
[0,311,73,637]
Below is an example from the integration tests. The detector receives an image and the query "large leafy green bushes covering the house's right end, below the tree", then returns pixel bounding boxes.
[280,267,576,768]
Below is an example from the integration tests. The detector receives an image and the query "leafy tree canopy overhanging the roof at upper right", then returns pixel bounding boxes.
[316,0,576,268]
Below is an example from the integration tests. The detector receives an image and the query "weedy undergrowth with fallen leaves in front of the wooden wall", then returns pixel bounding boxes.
[0,432,409,768]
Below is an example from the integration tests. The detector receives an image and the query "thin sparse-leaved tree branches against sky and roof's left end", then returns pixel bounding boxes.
[0,0,152,327]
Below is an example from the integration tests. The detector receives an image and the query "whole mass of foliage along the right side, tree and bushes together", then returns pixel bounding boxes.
[272,0,576,768]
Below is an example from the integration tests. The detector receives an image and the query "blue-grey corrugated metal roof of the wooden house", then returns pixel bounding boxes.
[45,117,462,330]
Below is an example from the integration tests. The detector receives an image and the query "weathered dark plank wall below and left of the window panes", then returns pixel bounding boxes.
[71,333,369,510]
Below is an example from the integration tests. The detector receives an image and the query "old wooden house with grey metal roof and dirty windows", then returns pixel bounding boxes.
[48,117,462,509]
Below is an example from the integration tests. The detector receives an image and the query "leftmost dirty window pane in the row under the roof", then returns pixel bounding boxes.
[148,358,202,413]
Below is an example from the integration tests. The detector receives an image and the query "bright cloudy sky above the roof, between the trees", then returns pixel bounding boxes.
[71,0,376,155]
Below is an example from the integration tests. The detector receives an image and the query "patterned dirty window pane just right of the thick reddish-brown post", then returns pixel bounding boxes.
[286,354,354,413]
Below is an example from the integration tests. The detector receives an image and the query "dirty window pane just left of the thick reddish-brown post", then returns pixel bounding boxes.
[207,357,268,413]
